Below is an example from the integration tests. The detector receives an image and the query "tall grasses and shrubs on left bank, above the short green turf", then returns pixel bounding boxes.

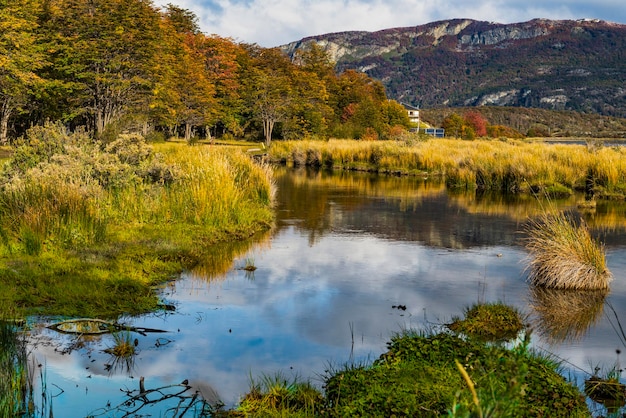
[0,125,274,254]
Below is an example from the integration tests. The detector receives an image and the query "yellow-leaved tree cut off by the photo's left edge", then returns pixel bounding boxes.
[0,0,43,144]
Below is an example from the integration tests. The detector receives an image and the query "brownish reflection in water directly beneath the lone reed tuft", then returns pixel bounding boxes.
[530,287,608,344]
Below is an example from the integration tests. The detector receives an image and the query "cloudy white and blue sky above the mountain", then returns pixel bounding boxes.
[154,0,626,48]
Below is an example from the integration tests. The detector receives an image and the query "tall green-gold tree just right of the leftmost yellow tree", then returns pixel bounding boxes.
[46,0,160,135]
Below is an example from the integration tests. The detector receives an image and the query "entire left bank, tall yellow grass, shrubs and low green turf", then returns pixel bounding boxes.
[0,125,273,316]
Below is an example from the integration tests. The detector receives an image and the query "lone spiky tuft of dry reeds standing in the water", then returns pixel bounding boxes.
[526,212,612,290]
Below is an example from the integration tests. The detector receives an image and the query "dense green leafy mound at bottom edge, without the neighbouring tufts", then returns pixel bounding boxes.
[325,332,589,417]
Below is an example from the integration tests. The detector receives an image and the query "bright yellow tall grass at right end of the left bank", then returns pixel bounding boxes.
[106,144,275,230]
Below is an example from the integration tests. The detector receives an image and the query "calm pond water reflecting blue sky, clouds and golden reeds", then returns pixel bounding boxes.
[26,169,626,418]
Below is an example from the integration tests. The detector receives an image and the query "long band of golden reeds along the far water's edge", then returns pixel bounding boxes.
[270,139,626,200]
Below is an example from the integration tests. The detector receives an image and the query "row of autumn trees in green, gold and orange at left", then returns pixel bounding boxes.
[0,0,409,144]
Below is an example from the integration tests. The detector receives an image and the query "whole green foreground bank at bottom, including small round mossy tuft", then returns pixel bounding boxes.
[222,303,590,417]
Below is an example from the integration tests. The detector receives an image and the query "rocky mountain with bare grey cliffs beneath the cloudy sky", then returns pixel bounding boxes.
[283,19,626,117]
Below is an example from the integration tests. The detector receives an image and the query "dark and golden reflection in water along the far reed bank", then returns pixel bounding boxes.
[275,167,626,249]
